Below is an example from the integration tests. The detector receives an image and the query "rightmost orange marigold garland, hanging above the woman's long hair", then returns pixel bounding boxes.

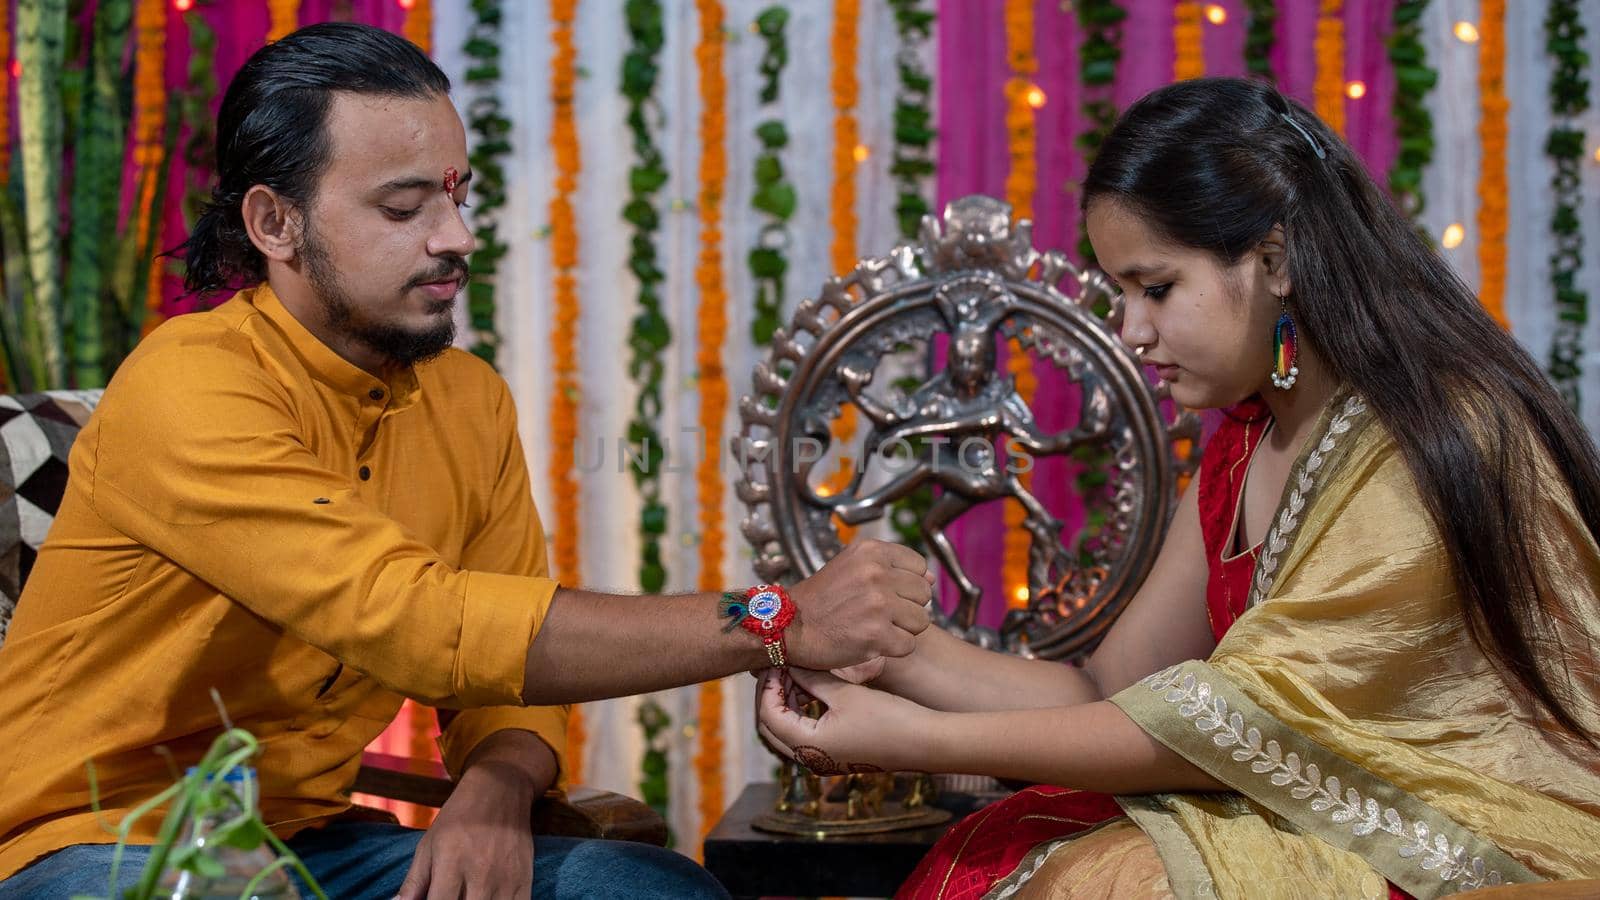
[1478,0,1510,328]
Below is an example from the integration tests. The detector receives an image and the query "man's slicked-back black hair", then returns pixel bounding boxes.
[176,22,450,295]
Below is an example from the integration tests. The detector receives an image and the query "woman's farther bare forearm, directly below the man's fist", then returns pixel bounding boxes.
[872,628,1101,713]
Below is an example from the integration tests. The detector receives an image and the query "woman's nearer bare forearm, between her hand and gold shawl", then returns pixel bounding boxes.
[928,701,1229,794]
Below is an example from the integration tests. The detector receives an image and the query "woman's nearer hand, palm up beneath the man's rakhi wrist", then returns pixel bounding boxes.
[757,669,939,775]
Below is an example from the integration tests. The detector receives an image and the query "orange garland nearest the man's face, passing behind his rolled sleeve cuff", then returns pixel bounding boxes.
[550,0,587,783]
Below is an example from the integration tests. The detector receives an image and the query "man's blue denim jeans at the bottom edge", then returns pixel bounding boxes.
[0,822,728,900]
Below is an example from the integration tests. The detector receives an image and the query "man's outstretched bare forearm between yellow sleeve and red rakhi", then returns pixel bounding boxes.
[523,588,771,706]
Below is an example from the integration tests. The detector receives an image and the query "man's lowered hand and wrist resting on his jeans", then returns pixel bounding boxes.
[397,732,555,900]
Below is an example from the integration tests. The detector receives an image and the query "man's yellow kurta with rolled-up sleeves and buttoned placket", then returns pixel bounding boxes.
[0,287,566,878]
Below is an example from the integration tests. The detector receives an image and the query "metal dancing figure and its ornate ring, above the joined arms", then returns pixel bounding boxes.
[731,195,1200,658]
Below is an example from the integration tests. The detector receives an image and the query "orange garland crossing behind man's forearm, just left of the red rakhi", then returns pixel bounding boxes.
[694,0,728,841]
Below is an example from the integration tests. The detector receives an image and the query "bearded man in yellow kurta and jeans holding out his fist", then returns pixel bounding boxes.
[0,24,930,900]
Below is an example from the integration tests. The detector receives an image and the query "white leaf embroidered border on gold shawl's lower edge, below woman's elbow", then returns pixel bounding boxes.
[1144,666,1507,890]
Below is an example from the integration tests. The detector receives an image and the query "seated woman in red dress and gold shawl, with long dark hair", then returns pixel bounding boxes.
[760,78,1600,897]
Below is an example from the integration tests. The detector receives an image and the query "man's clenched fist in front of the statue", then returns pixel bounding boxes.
[787,541,933,671]
